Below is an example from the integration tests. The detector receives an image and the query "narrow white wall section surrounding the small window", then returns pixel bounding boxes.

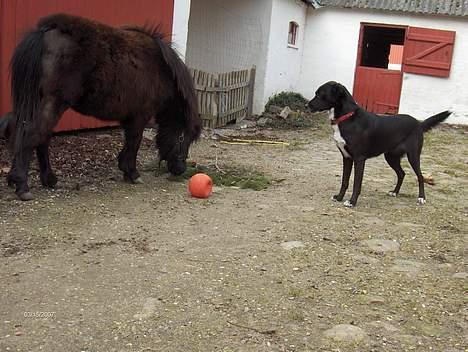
[263,0,307,107]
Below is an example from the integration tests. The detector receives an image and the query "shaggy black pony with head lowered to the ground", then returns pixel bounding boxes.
[8,14,201,200]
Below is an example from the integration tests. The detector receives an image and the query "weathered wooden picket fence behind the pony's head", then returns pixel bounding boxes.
[190,67,255,128]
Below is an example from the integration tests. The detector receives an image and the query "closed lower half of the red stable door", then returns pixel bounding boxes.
[353,66,403,114]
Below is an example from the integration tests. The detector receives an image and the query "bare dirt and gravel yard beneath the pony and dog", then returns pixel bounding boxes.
[0,117,468,352]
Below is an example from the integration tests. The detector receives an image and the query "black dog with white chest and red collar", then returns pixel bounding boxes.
[307,82,451,207]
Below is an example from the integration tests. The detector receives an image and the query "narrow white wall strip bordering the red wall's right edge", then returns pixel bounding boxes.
[172,0,190,59]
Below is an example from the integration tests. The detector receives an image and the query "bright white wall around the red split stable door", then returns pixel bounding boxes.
[298,8,468,124]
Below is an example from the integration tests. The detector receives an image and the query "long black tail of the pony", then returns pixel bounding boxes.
[10,29,44,152]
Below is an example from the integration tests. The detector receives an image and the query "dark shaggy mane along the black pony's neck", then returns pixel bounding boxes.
[121,24,201,139]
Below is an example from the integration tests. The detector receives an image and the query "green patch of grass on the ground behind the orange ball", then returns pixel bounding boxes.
[158,165,272,191]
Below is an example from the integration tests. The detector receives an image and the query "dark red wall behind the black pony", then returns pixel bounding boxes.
[0,0,174,131]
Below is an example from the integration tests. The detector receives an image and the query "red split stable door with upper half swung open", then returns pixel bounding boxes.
[353,24,455,114]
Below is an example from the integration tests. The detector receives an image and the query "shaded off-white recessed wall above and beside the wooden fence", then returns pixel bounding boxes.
[186,0,273,113]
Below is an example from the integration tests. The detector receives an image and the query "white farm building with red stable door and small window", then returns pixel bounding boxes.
[173,0,468,124]
